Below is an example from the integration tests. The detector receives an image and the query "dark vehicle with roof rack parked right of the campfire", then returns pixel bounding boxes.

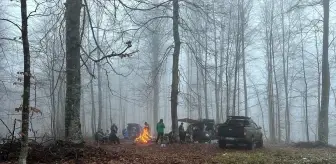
[217,116,263,150]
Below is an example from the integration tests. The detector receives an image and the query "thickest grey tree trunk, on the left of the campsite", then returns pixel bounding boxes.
[65,0,83,143]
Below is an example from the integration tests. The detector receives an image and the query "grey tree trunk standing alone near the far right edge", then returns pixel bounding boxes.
[318,0,330,144]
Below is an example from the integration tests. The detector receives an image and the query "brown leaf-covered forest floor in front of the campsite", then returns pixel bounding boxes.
[0,141,336,164]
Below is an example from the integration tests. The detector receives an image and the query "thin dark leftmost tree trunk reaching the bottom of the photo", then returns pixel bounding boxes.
[19,0,31,164]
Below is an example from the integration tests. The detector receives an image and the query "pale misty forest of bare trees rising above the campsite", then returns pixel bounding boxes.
[0,0,336,161]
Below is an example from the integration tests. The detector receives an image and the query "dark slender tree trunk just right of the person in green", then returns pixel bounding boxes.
[171,0,181,140]
